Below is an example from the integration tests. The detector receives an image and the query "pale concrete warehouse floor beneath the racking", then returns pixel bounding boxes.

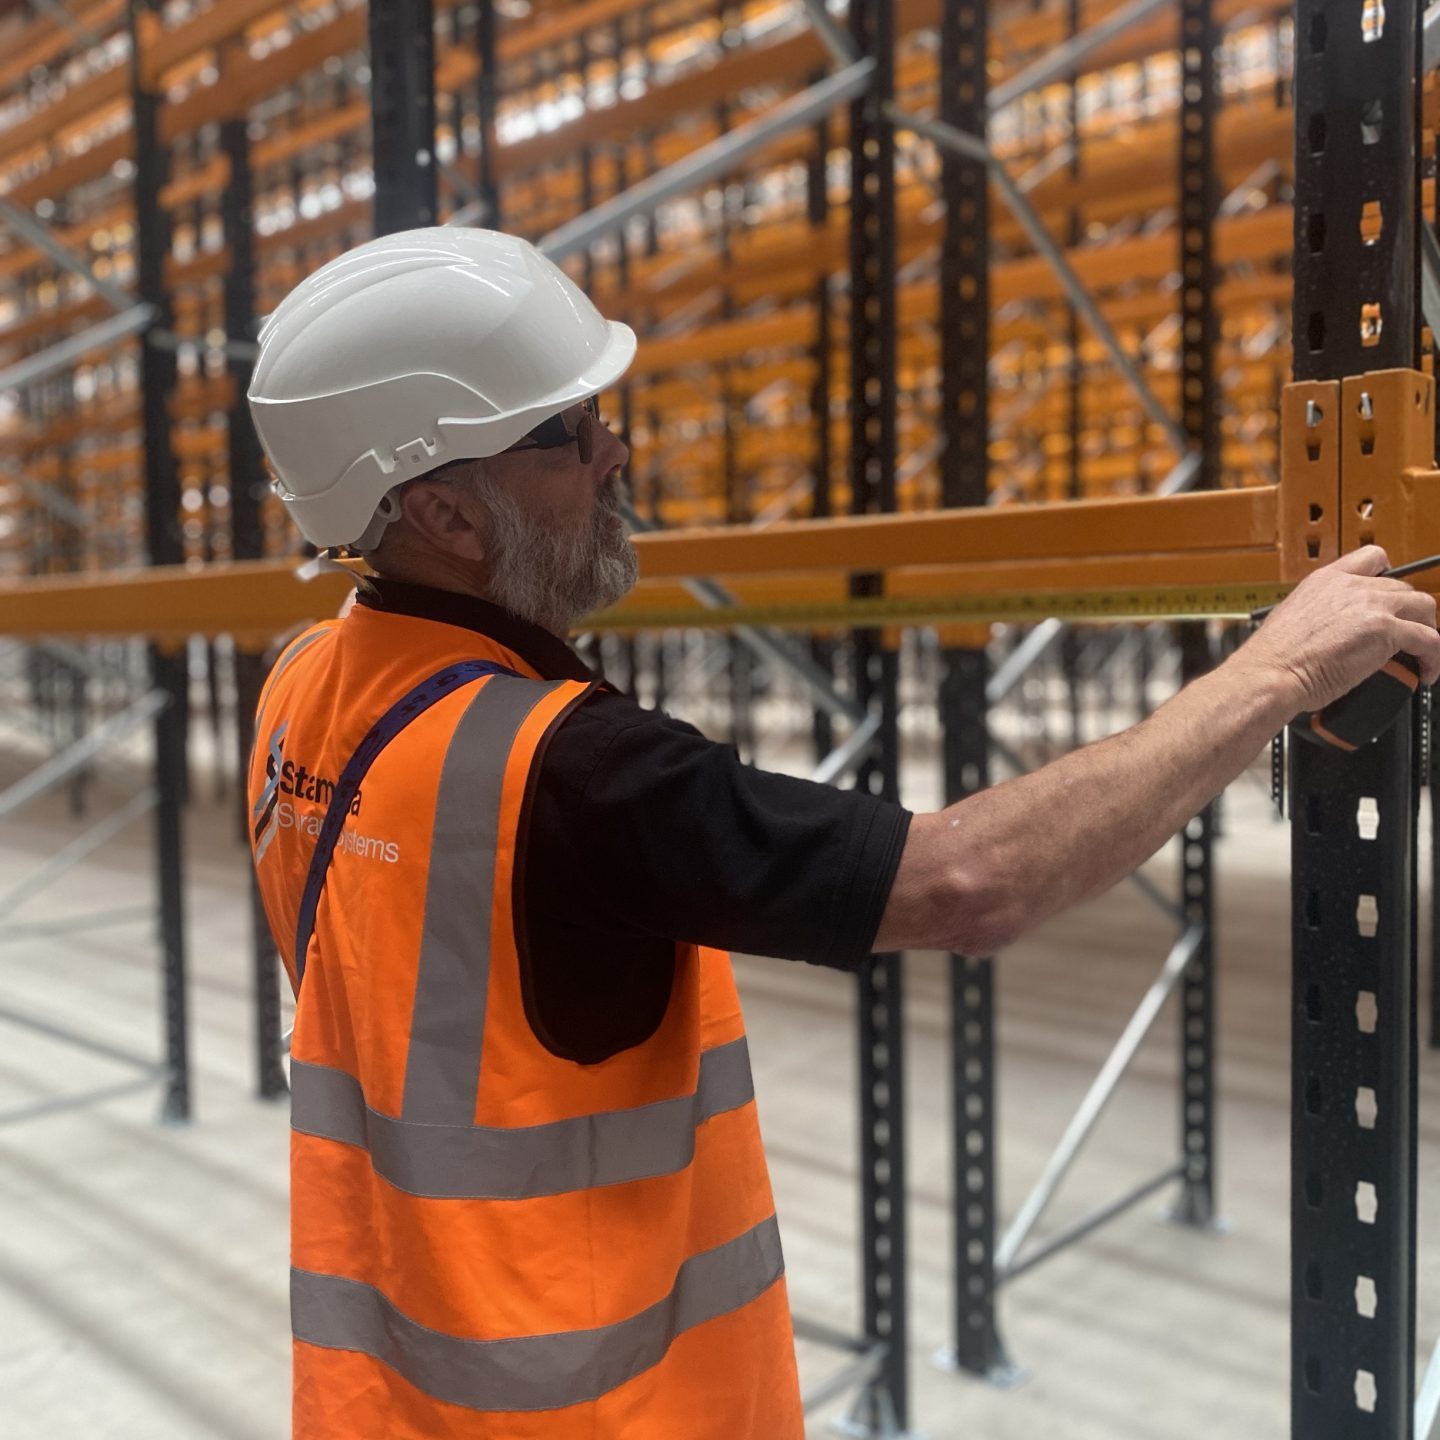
[0,731,1440,1440]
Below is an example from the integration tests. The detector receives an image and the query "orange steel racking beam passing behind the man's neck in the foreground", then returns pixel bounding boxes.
[0,488,1279,639]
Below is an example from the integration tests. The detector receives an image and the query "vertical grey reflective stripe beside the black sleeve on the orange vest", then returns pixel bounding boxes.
[400,675,563,1125]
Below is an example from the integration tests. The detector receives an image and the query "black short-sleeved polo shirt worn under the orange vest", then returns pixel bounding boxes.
[359,579,910,1063]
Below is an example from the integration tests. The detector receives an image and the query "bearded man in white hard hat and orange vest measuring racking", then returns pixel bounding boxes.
[251,229,1440,1440]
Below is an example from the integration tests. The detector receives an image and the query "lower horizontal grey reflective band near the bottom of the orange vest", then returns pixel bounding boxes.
[289,1215,785,1411]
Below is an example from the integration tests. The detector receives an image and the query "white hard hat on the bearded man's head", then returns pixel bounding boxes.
[249,226,635,546]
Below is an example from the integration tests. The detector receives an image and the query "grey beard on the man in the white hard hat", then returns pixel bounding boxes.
[474,477,639,635]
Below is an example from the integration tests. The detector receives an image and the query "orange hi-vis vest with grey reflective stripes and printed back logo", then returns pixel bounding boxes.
[249,606,804,1440]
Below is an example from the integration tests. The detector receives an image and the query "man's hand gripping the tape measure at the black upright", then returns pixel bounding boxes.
[1234,544,1440,711]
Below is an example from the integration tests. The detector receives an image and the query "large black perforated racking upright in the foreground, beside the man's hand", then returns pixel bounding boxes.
[1289,0,1421,1440]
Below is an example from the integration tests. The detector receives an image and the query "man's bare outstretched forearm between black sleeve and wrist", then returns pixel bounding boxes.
[876,657,1300,955]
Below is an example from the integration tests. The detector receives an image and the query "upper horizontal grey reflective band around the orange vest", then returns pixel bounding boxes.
[289,1037,755,1200]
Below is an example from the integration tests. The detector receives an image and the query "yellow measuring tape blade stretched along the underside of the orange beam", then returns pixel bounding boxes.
[580,585,1290,631]
